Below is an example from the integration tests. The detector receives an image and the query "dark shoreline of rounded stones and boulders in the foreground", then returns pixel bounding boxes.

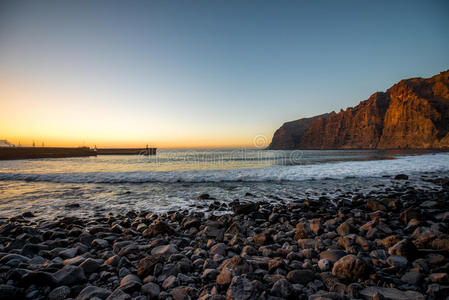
[0,175,449,300]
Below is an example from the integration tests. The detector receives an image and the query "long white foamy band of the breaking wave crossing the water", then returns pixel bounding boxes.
[0,153,449,183]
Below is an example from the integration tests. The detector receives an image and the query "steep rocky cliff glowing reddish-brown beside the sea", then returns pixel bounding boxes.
[269,70,449,150]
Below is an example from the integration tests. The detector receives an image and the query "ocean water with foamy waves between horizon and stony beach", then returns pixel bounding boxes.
[0,149,449,218]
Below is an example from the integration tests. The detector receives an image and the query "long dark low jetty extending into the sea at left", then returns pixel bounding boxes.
[0,147,157,160]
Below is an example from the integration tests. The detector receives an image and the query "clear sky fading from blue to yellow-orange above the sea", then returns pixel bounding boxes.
[0,0,449,148]
